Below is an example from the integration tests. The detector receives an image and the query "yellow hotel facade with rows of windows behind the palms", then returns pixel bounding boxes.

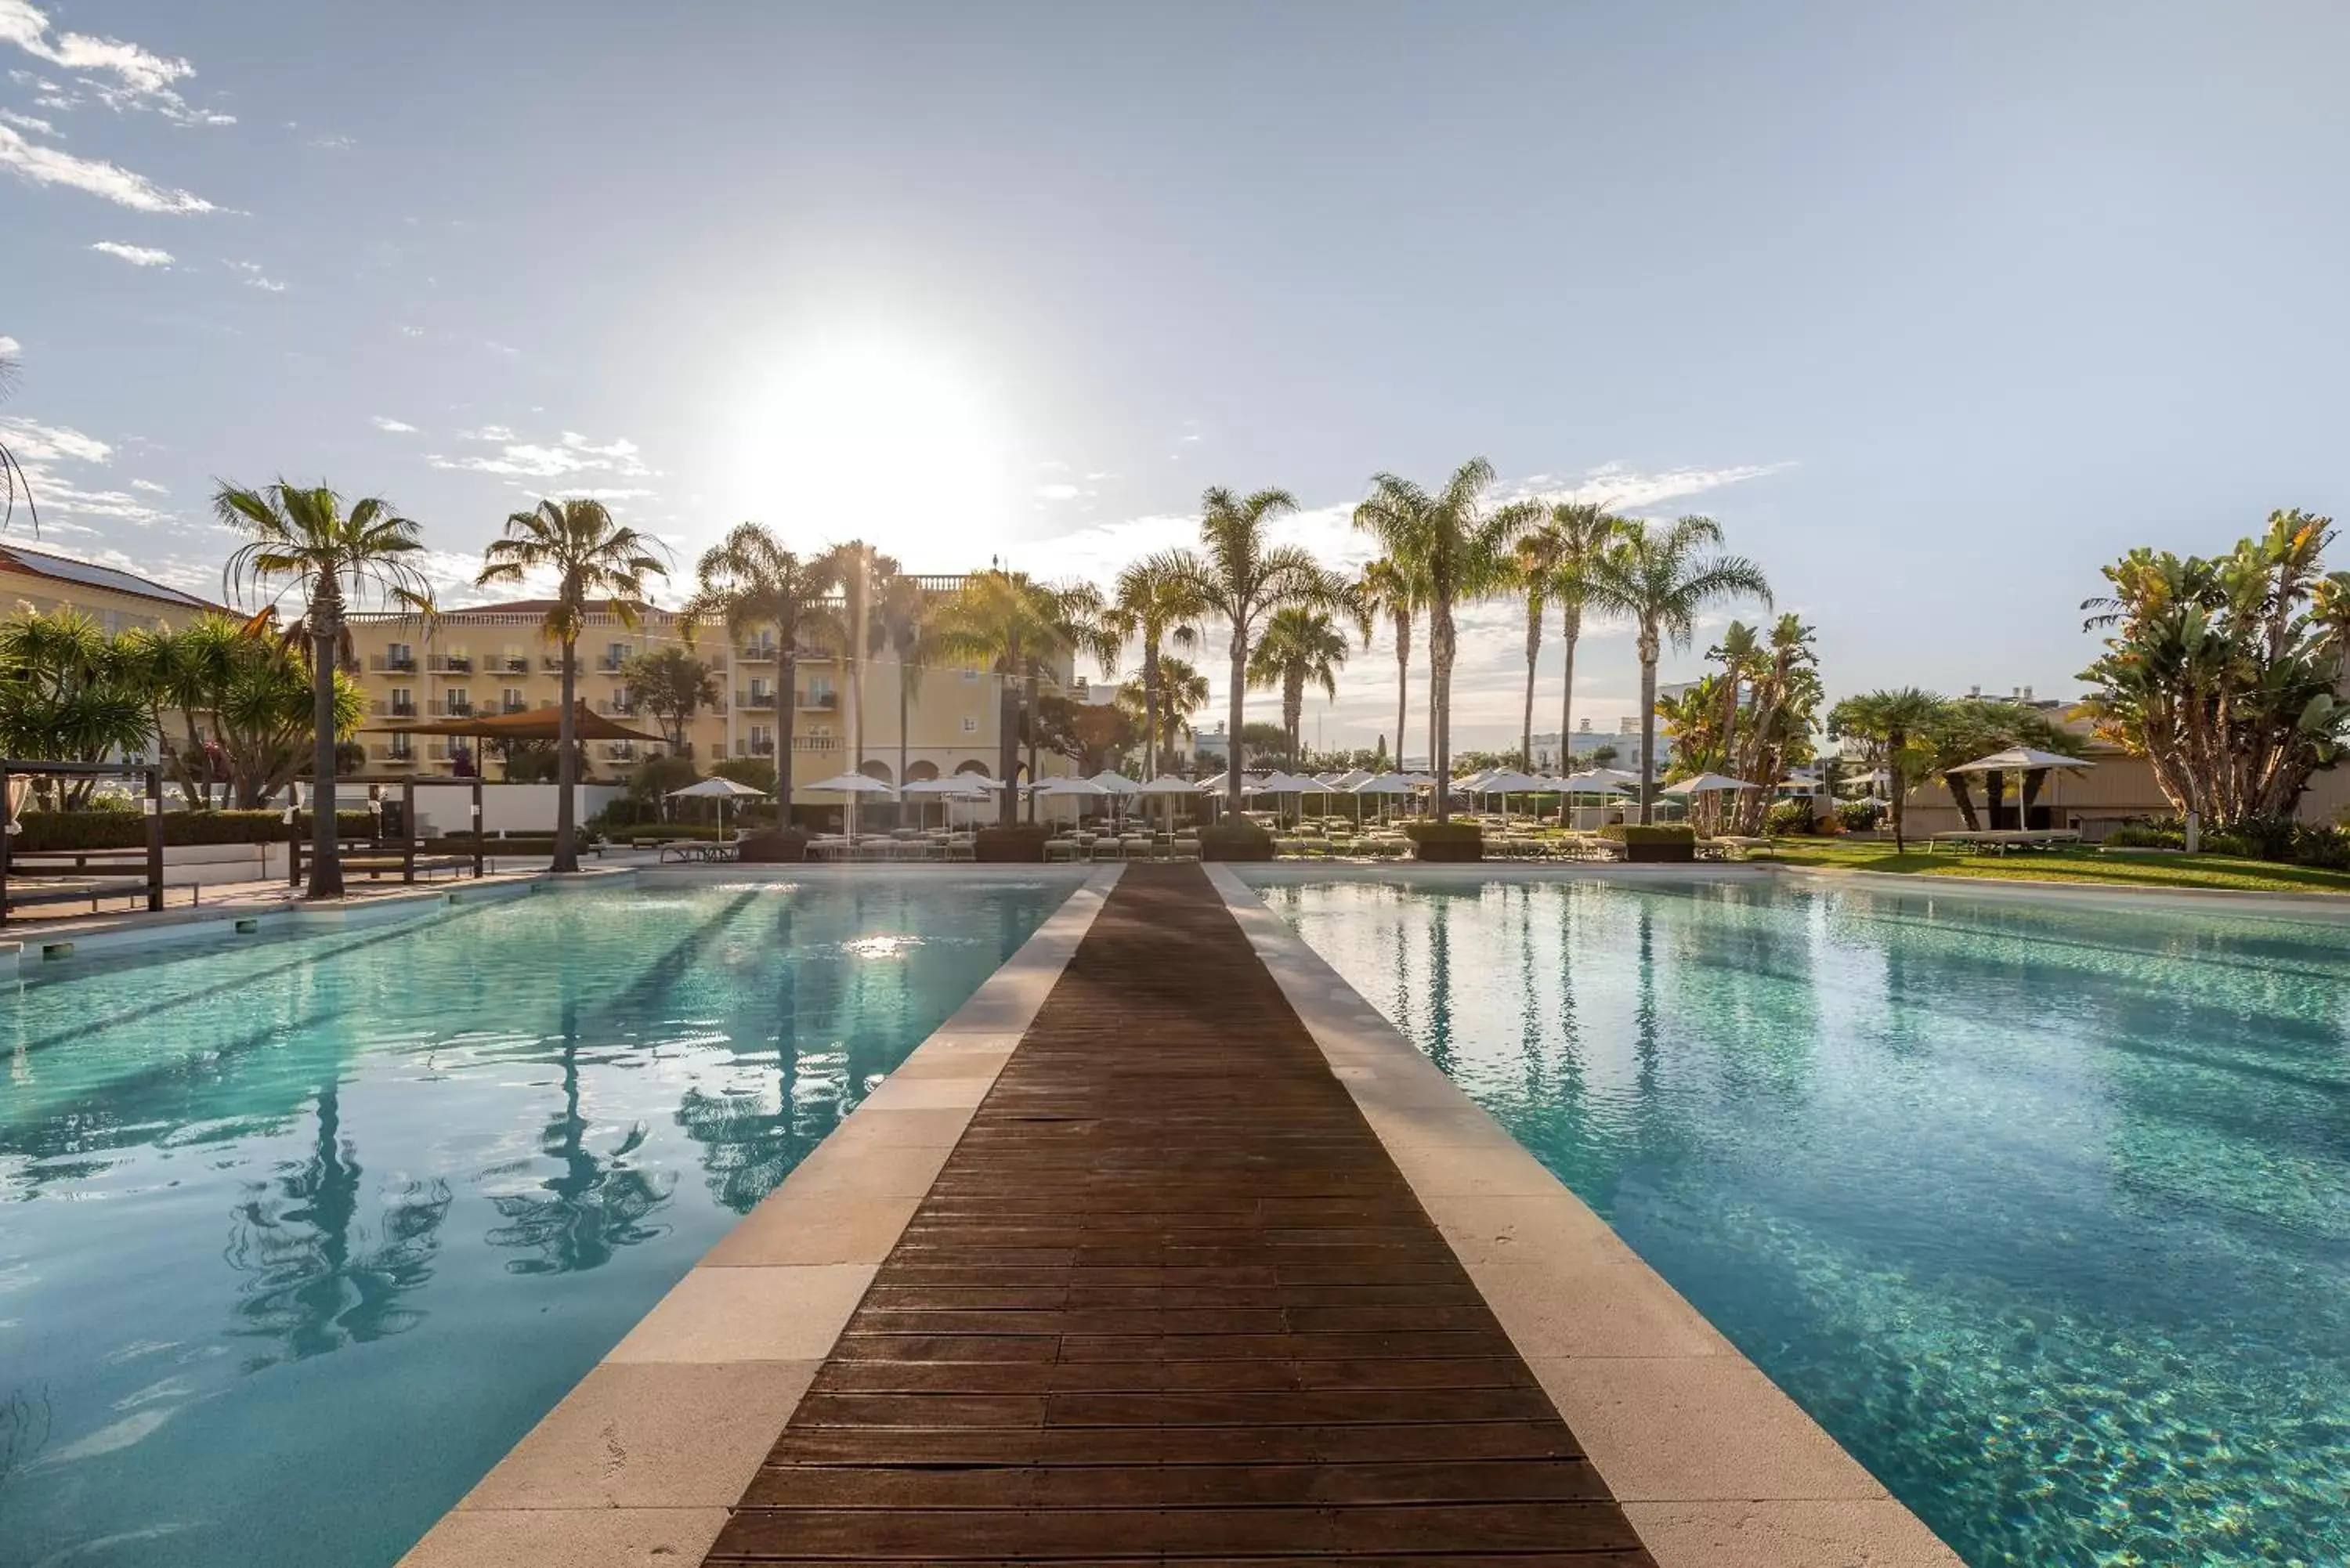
[350,576,1086,788]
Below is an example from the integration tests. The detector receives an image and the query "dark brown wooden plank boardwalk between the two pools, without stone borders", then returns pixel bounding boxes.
[707,865,1652,1568]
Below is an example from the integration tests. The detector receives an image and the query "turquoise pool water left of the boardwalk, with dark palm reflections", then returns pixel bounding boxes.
[0,873,1076,1568]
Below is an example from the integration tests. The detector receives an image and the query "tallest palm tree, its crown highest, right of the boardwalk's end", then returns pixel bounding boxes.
[1354,458,1546,823]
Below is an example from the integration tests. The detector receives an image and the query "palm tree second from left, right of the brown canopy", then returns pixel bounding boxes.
[472,498,670,873]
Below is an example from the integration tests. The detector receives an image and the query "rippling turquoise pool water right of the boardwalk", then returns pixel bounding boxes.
[1250,873,2350,1568]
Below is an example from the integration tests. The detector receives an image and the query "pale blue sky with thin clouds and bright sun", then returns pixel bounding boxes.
[0,0,2350,750]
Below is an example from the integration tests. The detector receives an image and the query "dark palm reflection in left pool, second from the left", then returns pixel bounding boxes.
[486,997,670,1274]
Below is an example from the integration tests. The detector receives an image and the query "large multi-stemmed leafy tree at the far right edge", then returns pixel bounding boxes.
[2082,510,2350,830]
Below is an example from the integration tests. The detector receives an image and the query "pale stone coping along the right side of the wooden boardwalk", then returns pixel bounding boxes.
[1208,865,1960,1568]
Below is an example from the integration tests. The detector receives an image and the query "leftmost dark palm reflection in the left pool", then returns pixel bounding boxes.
[226,1079,451,1371]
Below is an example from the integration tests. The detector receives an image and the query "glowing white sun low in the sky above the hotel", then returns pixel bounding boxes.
[728,334,1010,571]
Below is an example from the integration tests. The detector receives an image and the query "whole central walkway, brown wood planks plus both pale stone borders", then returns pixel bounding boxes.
[404,865,1958,1568]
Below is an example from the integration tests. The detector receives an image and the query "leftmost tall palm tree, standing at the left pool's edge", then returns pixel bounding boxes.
[212,479,432,898]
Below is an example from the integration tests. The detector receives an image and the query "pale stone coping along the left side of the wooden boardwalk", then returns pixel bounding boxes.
[400,865,1123,1568]
